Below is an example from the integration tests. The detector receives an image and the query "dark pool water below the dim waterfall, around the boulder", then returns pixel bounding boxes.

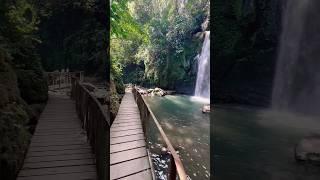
[211,107,320,180]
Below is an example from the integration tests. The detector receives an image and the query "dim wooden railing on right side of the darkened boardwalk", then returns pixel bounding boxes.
[71,77,110,180]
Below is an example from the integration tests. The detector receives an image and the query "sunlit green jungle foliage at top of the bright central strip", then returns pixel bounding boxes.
[110,0,209,92]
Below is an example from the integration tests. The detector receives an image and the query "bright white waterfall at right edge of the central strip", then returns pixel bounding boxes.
[195,31,210,99]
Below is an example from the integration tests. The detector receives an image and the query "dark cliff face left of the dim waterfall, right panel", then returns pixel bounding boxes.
[212,0,282,106]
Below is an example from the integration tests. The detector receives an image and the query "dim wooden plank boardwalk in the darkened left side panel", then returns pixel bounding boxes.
[17,94,97,180]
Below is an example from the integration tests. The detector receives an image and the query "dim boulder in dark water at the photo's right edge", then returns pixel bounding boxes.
[294,134,320,165]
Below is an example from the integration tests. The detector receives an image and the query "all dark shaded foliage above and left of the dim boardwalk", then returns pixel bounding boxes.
[0,0,110,180]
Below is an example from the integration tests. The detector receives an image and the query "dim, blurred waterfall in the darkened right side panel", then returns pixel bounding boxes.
[272,0,320,114]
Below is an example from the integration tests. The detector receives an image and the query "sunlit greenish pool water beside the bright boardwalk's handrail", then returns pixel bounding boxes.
[144,95,210,179]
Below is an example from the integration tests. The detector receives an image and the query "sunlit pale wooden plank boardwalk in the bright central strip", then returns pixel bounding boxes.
[110,89,152,180]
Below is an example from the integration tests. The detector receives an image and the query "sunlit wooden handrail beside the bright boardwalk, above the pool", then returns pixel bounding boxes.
[132,87,187,180]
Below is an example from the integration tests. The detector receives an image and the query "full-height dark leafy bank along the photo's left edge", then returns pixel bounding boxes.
[0,0,48,180]
